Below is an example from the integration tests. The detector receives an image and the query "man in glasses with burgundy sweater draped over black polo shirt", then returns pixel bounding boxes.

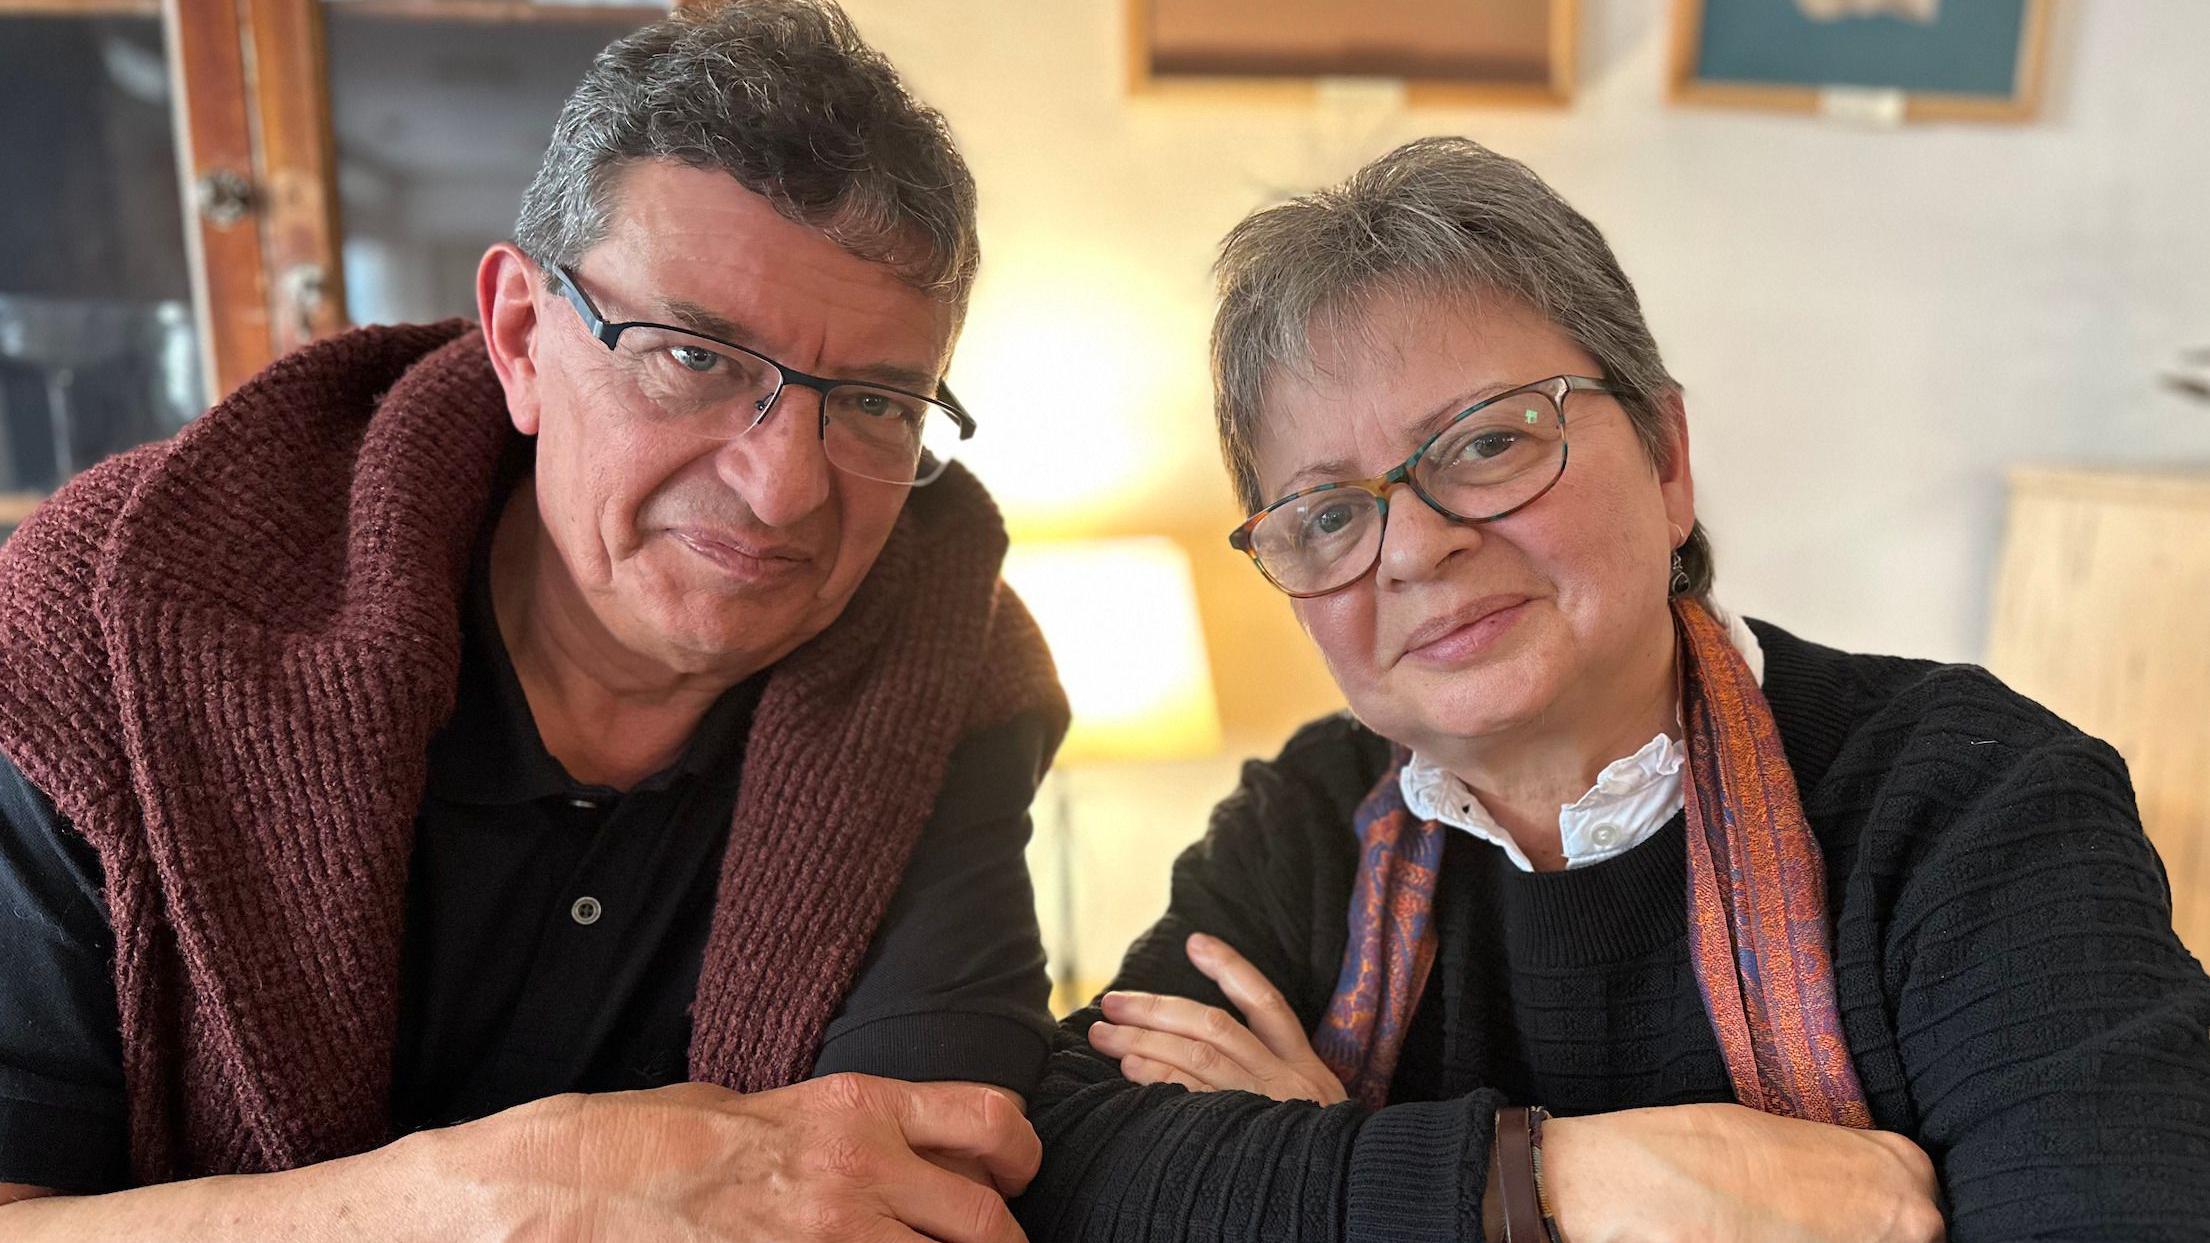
[0,0,1065,1241]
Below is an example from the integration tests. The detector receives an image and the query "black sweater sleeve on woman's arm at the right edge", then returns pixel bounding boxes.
[1890,734,2210,1243]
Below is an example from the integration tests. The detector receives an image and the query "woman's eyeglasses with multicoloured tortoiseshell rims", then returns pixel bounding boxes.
[1229,376,1616,597]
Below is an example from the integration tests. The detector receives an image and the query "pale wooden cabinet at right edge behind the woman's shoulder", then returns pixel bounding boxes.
[1987,469,2210,958]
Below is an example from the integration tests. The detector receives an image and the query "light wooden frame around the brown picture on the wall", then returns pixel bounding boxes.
[1127,0,1580,106]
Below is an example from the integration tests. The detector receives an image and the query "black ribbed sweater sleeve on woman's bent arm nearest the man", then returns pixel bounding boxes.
[1014,719,1503,1243]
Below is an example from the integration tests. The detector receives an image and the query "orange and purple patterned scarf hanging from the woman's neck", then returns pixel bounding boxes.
[1313,599,1872,1128]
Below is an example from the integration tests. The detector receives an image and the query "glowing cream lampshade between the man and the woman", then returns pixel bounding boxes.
[1006,535,1220,763]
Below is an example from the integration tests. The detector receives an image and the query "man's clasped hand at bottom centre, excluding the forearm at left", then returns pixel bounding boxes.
[402,1075,1041,1243]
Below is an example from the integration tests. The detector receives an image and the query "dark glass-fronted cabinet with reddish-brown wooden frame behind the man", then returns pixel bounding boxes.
[0,0,670,526]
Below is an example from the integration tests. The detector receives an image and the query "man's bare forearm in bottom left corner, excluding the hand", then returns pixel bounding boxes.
[0,1139,462,1243]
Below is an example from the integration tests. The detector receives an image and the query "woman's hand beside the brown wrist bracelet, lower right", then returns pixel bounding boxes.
[1543,1106,1943,1243]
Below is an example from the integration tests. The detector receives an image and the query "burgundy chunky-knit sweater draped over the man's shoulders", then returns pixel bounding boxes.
[0,321,1065,1181]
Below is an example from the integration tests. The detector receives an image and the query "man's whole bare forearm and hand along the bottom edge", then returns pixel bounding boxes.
[0,1075,1043,1243]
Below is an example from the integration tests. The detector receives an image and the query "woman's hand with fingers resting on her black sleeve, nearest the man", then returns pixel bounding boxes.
[1090,933,1344,1106]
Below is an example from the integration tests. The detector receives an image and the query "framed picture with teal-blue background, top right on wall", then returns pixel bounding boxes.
[1669,0,2051,122]
